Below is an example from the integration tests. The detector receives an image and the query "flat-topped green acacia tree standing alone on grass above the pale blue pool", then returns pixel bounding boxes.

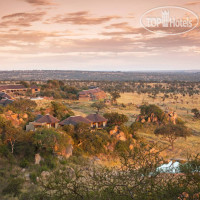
[154,123,191,150]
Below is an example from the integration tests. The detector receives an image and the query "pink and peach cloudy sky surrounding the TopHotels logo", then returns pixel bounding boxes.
[0,0,200,71]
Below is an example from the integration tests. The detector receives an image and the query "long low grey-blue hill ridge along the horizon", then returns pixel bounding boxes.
[0,70,200,82]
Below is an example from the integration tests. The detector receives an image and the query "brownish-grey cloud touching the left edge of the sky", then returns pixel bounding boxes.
[0,12,46,28]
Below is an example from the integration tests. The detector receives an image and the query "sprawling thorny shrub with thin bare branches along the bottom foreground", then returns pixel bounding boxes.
[35,144,200,200]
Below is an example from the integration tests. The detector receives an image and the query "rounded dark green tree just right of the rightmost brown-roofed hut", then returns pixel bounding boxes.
[104,112,128,126]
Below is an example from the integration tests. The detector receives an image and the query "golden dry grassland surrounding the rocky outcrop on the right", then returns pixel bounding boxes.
[35,93,200,159]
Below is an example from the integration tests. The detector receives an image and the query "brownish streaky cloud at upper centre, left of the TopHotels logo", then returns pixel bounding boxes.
[47,11,119,25]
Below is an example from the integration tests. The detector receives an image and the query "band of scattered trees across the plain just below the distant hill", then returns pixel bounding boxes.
[16,80,200,100]
